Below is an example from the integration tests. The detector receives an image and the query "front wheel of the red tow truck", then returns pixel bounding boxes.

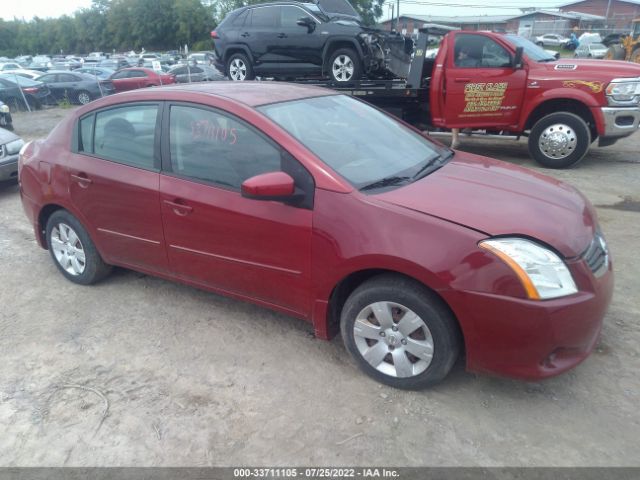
[529,112,591,168]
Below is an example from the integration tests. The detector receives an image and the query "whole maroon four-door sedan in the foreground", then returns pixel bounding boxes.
[19,82,613,388]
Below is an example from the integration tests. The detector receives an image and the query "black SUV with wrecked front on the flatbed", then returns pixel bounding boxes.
[211,0,413,83]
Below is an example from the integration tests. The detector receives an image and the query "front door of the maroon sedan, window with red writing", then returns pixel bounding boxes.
[160,104,313,313]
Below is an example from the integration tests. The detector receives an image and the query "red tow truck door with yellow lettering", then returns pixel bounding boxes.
[443,32,527,128]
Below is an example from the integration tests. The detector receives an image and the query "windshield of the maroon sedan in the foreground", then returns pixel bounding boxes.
[258,95,452,190]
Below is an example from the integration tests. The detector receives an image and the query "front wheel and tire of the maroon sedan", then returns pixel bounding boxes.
[340,274,461,390]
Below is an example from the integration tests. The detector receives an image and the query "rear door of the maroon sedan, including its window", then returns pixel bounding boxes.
[69,103,167,271]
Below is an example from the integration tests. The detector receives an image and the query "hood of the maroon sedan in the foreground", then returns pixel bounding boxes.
[375,152,596,258]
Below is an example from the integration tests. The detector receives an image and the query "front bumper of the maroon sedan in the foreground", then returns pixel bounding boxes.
[443,260,613,380]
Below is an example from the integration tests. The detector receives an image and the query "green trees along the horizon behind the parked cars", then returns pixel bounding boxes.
[0,0,384,57]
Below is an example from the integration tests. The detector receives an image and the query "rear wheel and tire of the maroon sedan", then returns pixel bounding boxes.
[46,210,111,285]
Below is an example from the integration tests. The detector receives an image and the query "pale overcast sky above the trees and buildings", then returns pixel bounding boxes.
[0,0,568,20]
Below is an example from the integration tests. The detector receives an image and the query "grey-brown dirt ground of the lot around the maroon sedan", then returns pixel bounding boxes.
[0,109,640,466]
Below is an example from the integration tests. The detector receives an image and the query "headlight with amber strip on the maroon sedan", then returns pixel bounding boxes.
[478,238,578,300]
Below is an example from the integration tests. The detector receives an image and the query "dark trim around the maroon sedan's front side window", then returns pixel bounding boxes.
[160,100,316,206]
